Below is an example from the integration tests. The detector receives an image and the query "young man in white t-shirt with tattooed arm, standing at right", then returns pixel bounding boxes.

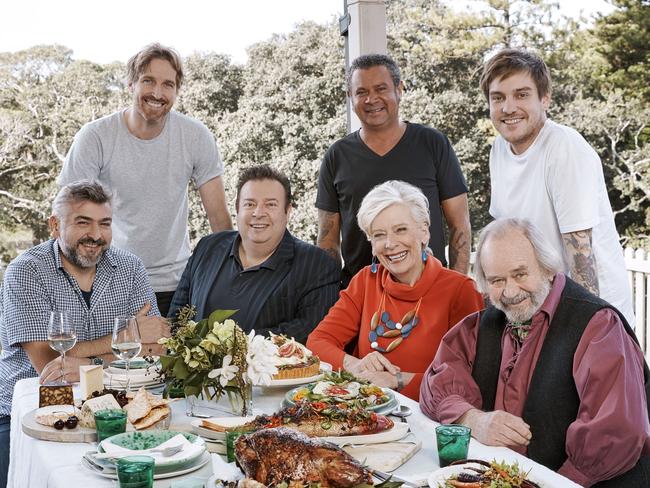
[480,49,635,327]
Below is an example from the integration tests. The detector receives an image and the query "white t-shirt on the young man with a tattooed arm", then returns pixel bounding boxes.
[490,120,635,327]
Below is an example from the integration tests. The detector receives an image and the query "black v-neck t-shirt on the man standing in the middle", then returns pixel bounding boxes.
[316,122,467,286]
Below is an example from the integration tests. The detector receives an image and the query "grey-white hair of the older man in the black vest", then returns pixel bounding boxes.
[475,218,564,293]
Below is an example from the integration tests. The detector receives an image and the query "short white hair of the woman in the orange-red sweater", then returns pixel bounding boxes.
[357,180,431,239]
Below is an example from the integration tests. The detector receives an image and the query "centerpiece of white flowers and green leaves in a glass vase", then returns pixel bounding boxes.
[158,305,278,416]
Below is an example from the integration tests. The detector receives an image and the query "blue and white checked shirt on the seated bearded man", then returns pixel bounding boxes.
[0,240,160,417]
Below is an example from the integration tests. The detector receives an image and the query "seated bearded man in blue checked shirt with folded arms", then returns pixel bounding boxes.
[0,181,169,488]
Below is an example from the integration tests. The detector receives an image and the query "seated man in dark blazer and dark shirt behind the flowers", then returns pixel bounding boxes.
[169,165,340,343]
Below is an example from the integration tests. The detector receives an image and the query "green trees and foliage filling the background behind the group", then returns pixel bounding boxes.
[0,0,650,264]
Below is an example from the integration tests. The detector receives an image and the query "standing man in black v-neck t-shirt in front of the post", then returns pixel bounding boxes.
[316,54,471,287]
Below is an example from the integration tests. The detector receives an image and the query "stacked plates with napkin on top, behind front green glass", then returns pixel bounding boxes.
[82,431,210,479]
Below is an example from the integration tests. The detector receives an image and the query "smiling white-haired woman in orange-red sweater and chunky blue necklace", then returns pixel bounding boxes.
[307,180,483,400]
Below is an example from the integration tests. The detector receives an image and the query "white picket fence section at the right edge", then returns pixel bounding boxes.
[625,247,650,360]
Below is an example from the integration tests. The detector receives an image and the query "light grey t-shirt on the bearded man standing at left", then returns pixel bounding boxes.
[58,110,223,292]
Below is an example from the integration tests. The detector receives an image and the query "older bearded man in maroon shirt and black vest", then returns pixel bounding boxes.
[420,219,650,487]
